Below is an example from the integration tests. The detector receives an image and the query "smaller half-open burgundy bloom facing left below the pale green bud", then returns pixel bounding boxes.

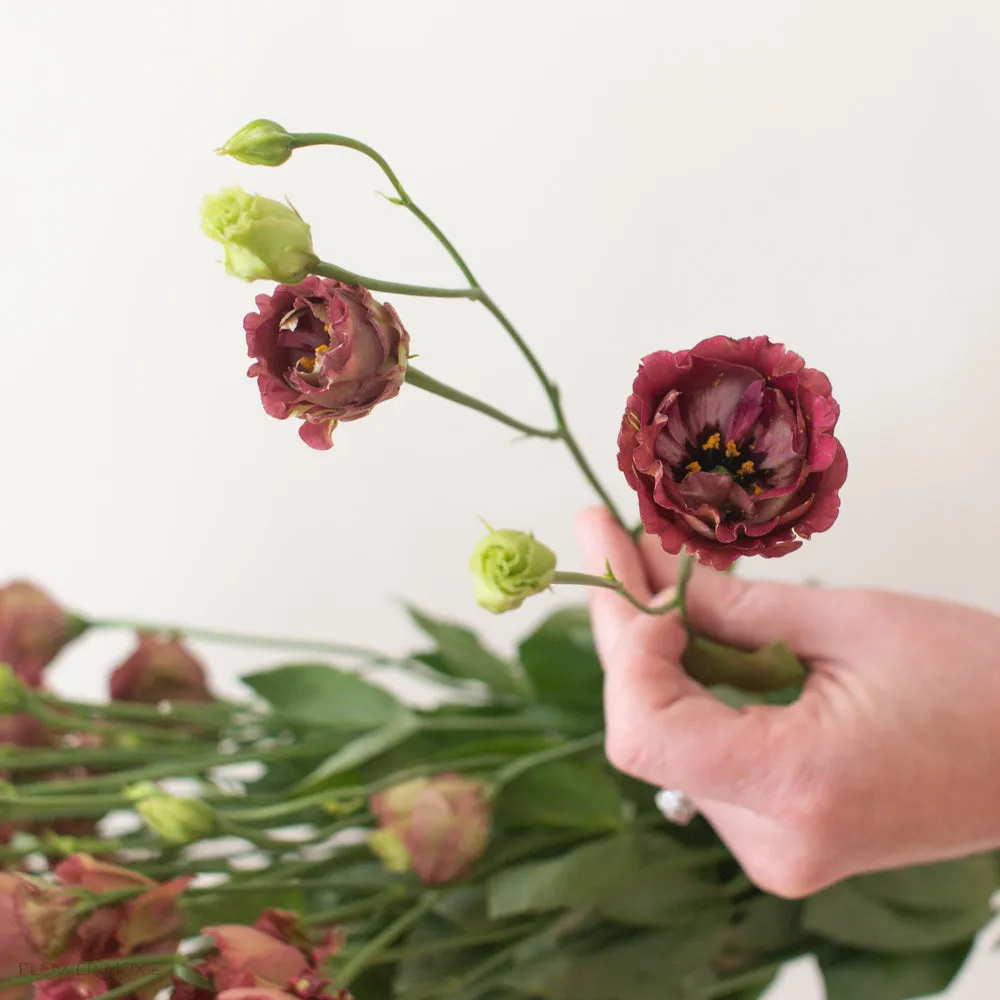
[243,275,410,450]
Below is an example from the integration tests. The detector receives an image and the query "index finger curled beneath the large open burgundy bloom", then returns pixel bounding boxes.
[639,535,844,659]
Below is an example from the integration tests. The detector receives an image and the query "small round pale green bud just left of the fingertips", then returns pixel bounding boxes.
[469,525,556,615]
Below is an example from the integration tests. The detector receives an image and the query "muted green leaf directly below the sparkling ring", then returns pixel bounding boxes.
[595,833,731,927]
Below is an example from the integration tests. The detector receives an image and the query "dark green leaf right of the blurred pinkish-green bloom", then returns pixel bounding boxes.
[496,759,624,830]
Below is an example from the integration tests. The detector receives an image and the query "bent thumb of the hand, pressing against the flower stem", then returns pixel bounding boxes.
[604,616,788,806]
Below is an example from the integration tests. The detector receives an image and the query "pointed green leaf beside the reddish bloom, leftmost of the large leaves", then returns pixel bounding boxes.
[243,663,407,730]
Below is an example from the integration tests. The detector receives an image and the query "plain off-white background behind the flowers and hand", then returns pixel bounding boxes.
[0,0,1000,998]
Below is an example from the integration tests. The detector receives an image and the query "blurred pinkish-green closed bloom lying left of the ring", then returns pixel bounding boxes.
[370,774,491,885]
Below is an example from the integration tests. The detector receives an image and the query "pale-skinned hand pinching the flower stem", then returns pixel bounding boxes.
[577,509,1000,898]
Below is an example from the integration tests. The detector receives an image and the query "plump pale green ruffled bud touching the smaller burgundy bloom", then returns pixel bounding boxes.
[201,187,319,285]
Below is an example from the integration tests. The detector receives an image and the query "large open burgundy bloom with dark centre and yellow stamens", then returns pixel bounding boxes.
[618,337,847,569]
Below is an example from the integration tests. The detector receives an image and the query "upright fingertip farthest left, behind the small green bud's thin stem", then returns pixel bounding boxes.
[576,507,652,660]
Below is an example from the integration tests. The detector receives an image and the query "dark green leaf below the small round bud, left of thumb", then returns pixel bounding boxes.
[518,607,604,711]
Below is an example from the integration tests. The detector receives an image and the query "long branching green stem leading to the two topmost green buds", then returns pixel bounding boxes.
[291,132,625,528]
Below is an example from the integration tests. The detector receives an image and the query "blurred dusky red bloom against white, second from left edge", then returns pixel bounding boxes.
[111,632,214,705]
